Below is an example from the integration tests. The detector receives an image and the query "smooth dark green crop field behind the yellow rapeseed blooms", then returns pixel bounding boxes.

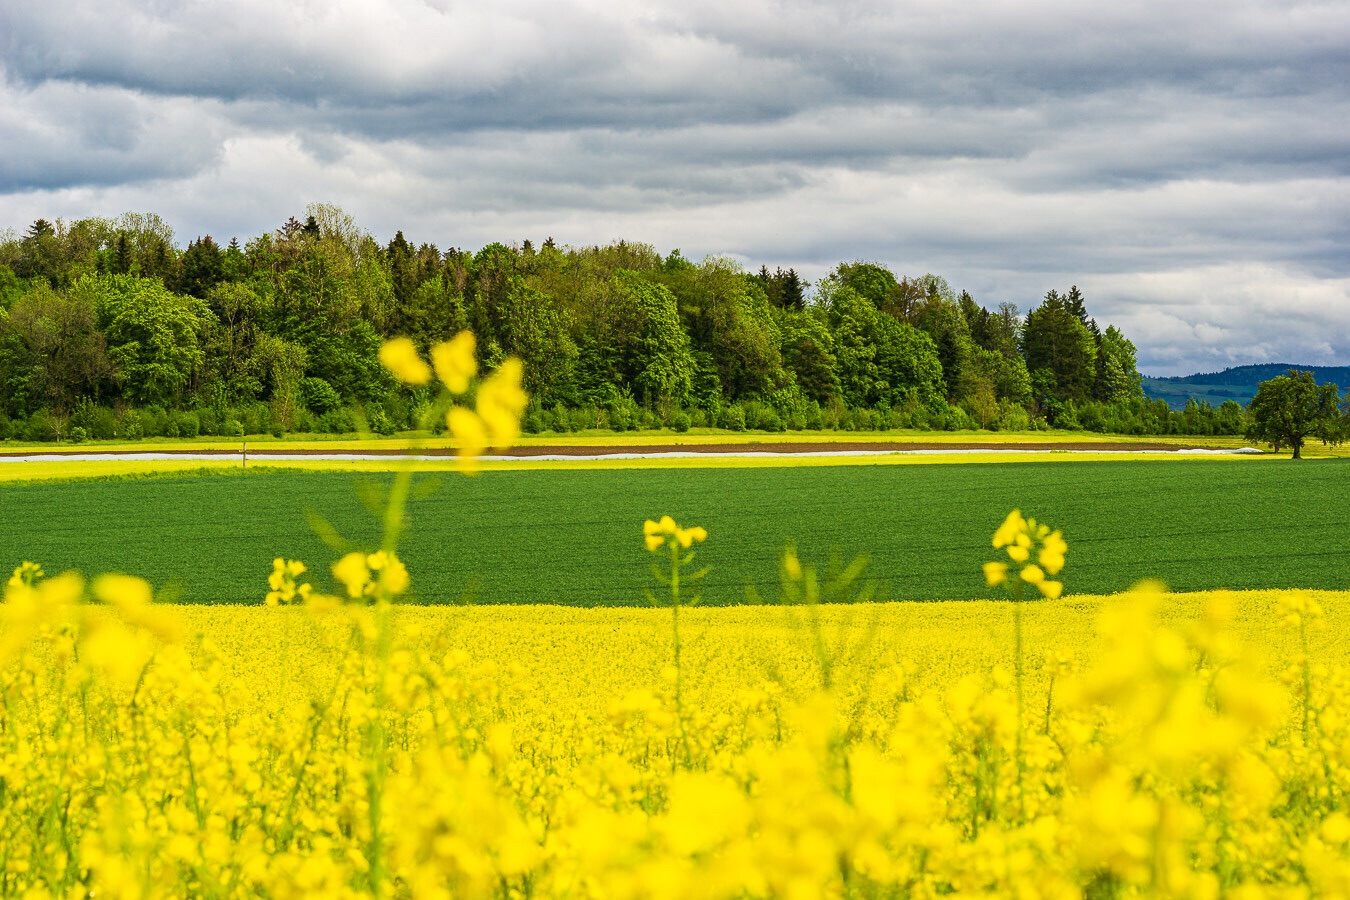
[0,460,1350,606]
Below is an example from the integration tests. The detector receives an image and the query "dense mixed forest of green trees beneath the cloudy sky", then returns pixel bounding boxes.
[0,204,1245,440]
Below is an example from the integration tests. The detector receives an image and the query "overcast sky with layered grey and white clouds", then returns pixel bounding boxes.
[0,0,1350,374]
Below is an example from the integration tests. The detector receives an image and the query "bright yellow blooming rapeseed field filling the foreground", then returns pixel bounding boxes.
[0,553,1350,899]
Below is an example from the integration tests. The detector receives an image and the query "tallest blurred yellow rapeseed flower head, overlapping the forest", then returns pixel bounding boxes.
[379,331,529,471]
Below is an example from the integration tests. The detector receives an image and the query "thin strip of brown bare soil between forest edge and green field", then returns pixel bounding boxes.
[0,441,1207,459]
